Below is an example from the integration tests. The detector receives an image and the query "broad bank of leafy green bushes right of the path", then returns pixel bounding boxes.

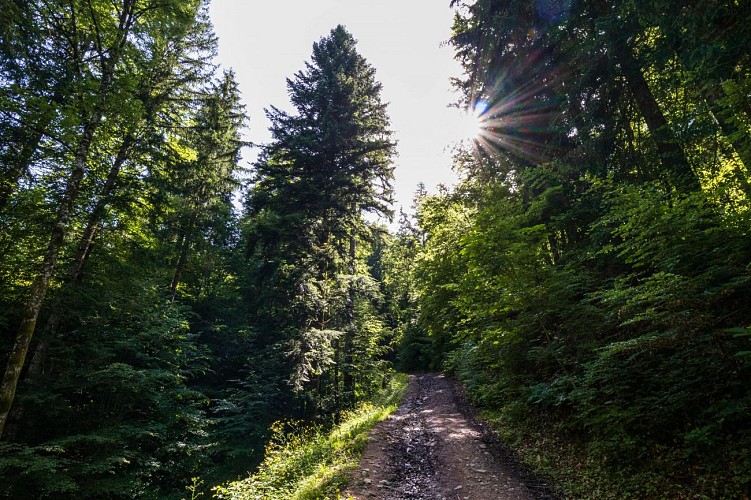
[417,175,751,498]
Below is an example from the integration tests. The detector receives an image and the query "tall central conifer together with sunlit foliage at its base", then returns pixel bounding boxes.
[244,26,395,417]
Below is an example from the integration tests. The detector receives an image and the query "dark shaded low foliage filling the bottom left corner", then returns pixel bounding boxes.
[0,299,210,498]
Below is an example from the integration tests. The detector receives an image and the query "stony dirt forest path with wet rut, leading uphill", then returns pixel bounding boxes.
[343,374,556,500]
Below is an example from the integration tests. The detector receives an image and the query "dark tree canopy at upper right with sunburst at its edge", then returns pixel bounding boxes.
[452,0,699,192]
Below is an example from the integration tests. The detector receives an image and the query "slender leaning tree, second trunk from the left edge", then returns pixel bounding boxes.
[22,6,220,379]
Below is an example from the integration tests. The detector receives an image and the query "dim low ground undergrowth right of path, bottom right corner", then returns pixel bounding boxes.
[480,404,748,500]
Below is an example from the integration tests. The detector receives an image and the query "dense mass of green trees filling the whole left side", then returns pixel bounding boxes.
[0,0,250,498]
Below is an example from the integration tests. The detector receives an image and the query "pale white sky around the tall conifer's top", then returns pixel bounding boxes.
[210,0,466,223]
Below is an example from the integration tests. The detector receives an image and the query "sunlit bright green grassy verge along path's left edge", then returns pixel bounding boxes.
[214,374,407,500]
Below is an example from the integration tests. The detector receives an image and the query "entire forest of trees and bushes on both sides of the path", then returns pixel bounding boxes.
[0,0,751,499]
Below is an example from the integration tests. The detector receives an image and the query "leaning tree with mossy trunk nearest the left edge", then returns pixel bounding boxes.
[0,0,206,433]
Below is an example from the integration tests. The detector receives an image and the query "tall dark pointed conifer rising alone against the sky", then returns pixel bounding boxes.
[247,26,395,410]
